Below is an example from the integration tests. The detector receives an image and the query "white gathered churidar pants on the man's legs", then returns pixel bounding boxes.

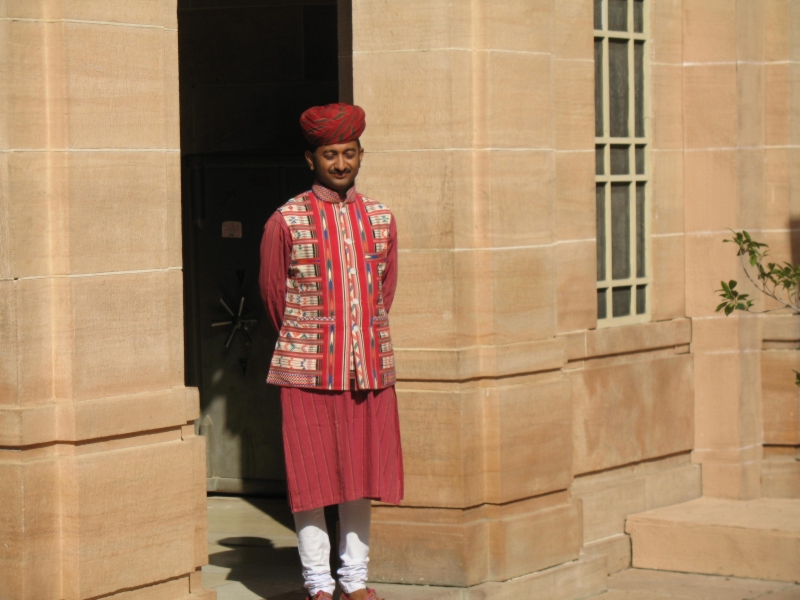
[294,498,372,597]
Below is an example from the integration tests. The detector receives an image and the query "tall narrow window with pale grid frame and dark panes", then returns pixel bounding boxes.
[594,0,652,327]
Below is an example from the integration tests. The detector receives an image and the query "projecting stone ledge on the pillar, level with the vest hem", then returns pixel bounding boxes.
[394,337,567,381]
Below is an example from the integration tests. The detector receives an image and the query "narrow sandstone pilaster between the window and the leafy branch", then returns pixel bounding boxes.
[683,0,790,499]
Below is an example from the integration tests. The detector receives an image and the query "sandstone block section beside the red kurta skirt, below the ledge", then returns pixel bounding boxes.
[399,380,571,508]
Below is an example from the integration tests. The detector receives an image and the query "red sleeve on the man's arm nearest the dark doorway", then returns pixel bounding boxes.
[258,212,292,332]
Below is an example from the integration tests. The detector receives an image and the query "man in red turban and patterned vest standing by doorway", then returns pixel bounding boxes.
[259,104,403,600]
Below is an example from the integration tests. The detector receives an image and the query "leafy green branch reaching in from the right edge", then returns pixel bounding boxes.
[716,230,800,386]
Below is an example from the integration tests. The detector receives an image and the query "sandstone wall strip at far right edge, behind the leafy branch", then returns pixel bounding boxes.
[761,0,800,498]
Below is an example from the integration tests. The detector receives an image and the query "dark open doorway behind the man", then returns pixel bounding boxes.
[178,0,340,495]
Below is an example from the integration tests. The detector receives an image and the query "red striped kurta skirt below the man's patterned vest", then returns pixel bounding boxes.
[281,387,403,512]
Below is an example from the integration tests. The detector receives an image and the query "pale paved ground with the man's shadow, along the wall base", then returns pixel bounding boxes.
[203,496,800,600]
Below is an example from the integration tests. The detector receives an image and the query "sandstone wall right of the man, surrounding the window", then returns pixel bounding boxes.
[353,0,700,585]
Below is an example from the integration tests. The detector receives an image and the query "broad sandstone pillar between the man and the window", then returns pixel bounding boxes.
[353,0,604,597]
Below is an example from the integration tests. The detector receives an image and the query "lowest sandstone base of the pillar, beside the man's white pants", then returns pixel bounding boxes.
[370,498,581,587]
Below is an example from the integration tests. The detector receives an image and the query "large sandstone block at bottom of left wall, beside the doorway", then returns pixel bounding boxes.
[64,442,198,598]
